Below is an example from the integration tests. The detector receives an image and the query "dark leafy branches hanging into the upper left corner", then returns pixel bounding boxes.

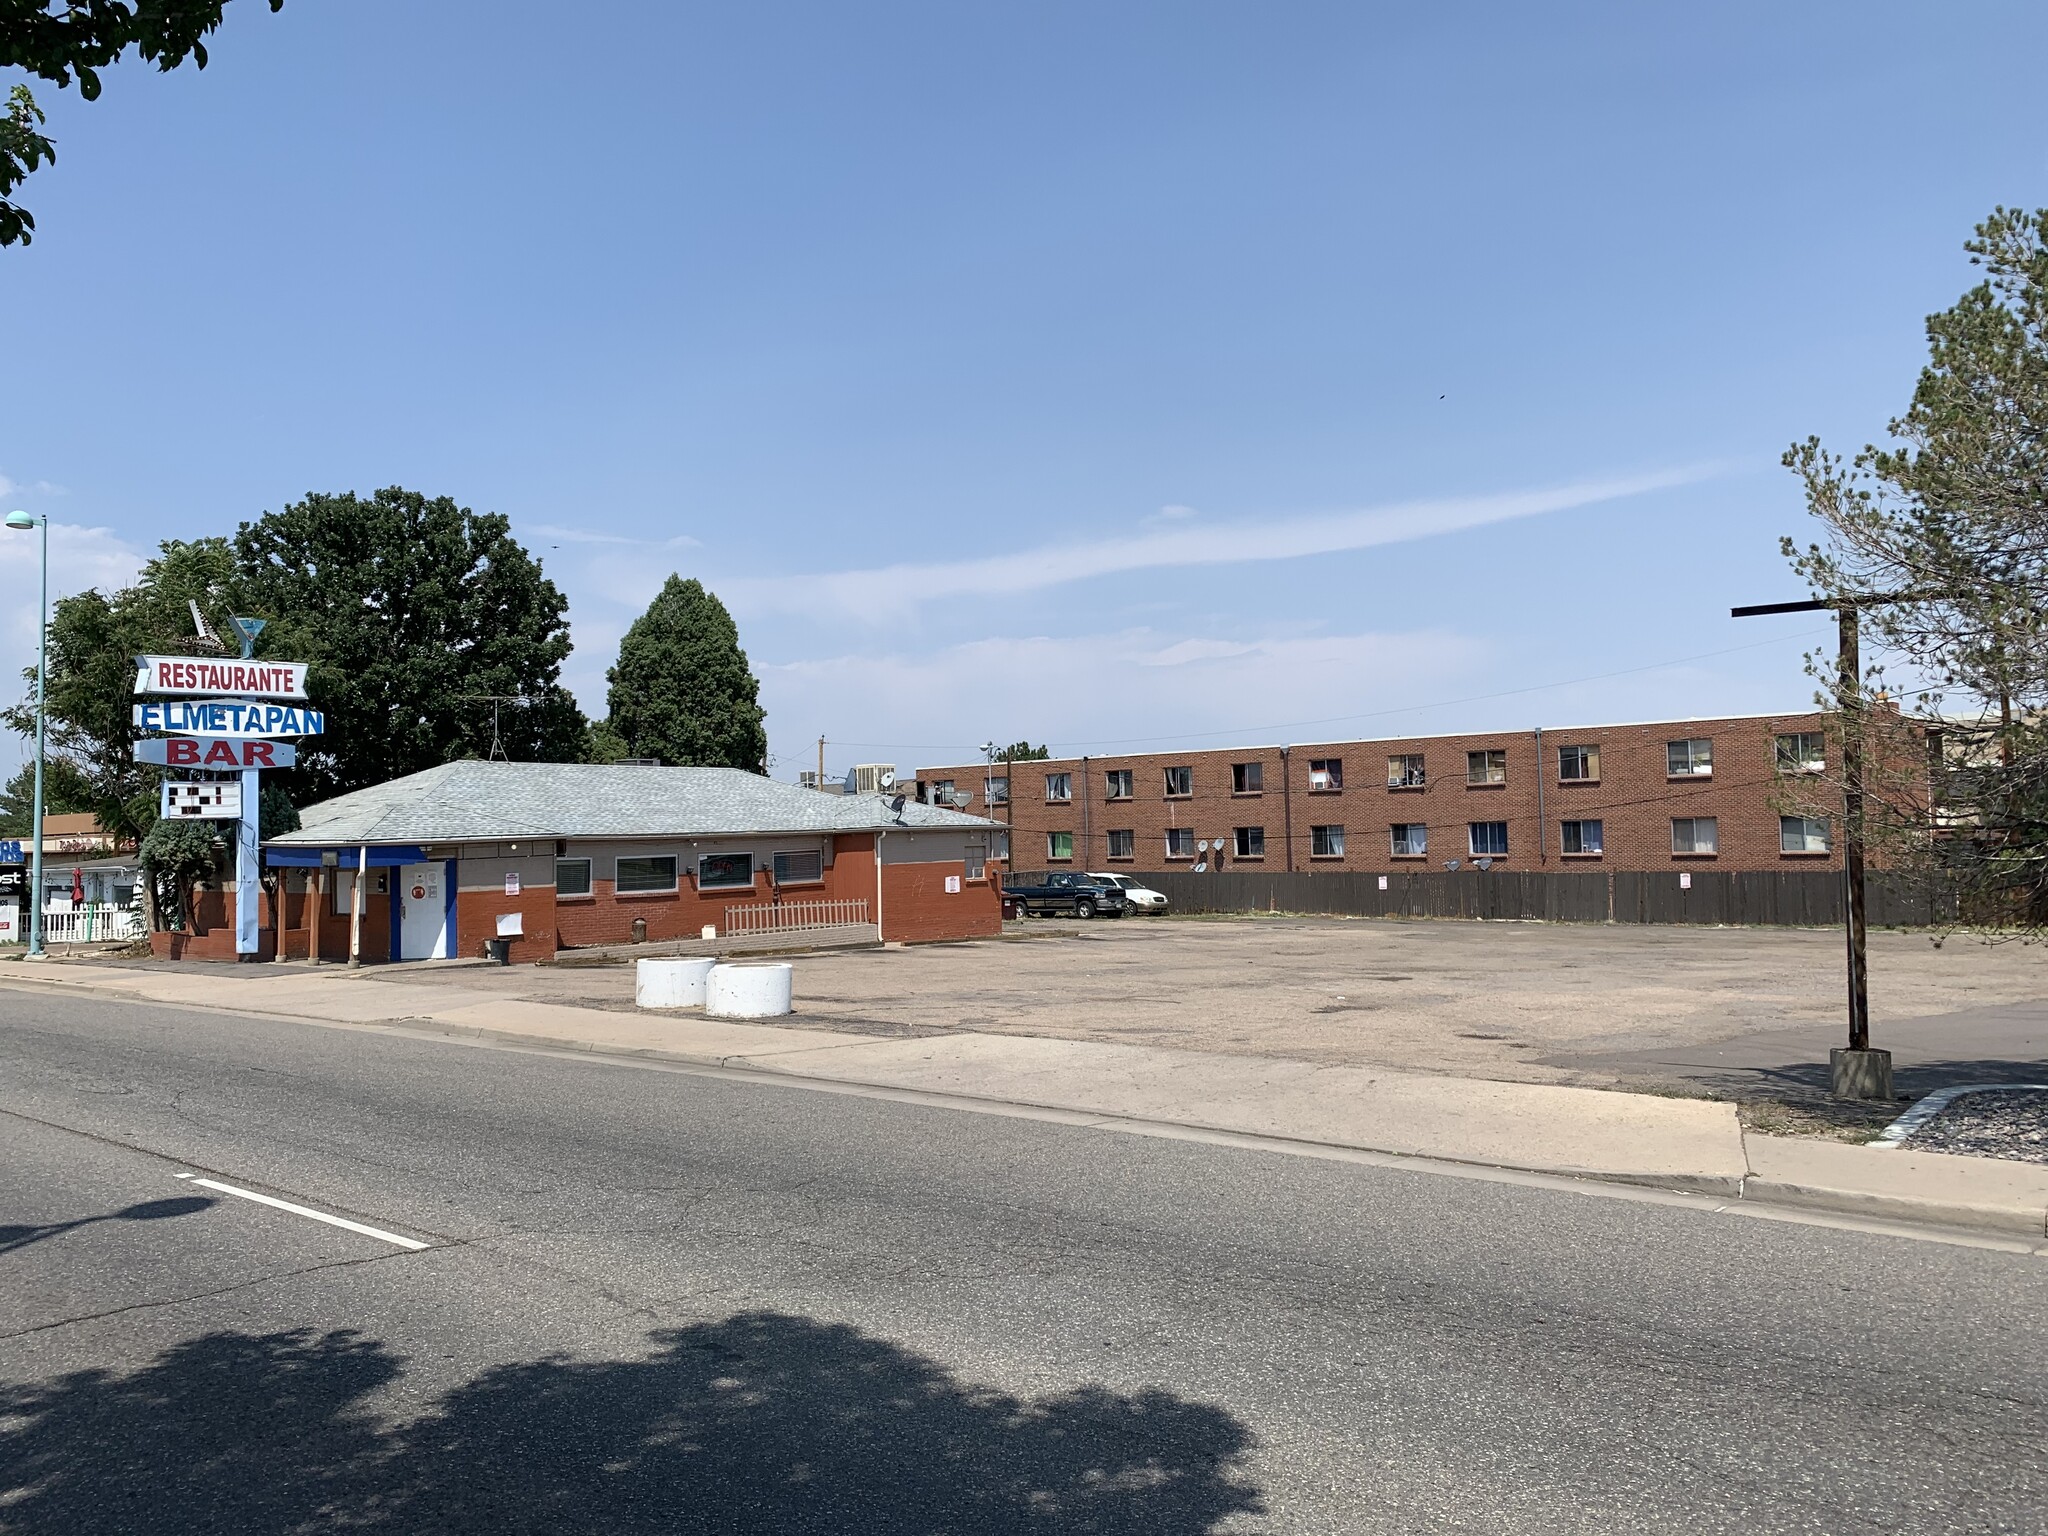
[0,0,285,246]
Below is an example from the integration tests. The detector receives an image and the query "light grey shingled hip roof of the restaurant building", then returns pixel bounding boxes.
[270,760,1001,848]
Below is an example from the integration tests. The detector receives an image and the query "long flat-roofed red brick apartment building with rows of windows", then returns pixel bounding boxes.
[918,711,1867,870]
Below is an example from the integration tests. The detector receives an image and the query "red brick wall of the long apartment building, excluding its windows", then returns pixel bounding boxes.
[918,711,1900,870]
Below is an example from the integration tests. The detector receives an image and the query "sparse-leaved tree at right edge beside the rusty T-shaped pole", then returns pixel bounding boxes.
[1786,209,2048,930]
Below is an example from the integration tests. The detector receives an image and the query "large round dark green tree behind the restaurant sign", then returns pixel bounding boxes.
[233,485,588,803]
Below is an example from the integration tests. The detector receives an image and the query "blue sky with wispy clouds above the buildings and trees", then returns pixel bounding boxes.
[0,0,2048,776]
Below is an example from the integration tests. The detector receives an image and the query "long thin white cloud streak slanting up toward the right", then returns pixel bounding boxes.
[719,469,1710,623]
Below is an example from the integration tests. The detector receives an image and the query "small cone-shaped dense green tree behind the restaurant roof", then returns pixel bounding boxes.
[606,575,768,774]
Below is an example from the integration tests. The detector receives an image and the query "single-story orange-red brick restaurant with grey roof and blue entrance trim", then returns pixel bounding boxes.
[262,760,1001,961]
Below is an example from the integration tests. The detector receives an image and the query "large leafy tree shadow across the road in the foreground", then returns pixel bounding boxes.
[0,1313,1262,1536]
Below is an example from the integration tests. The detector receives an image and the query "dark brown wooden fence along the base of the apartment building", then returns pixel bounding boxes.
[1048,868,1956,928]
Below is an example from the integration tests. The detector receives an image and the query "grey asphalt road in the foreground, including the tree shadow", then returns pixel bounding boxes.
[0,987,2048,1536]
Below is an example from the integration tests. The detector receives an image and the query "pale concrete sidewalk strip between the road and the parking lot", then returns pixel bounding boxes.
[0,965,2048,1251]
